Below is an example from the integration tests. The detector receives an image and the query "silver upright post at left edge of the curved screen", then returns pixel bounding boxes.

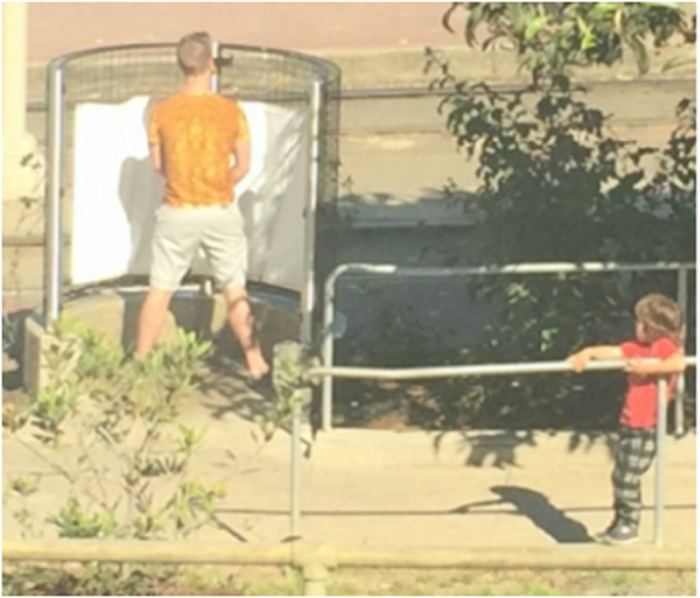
[44,65,65,328]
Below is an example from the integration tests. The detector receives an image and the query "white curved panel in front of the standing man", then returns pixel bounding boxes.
[71,97,309,291]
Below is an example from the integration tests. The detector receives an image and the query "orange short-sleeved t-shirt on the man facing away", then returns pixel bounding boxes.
[148,93,249,207]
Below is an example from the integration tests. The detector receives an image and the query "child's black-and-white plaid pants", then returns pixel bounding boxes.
[612,427,656,528]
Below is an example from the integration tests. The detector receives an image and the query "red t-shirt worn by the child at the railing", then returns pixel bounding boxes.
[620,337,679,428]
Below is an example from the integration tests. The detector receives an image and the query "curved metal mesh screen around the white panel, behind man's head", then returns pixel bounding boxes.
[54,44,340,292]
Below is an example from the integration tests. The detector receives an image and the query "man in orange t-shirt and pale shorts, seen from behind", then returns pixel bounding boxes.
[136,33,270,379]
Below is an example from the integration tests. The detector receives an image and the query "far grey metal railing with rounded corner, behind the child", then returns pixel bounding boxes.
[321,262,696,435]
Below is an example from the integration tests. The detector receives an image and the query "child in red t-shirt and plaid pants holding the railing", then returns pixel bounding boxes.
[569,294,685,544]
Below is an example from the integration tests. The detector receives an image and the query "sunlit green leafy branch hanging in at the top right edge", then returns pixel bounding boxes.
[443,2,695,83]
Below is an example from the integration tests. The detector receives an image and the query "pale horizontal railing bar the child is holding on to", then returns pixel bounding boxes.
[309,357,696,380]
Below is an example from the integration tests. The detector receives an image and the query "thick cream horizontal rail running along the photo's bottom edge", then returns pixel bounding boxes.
[2,540,696,570]
